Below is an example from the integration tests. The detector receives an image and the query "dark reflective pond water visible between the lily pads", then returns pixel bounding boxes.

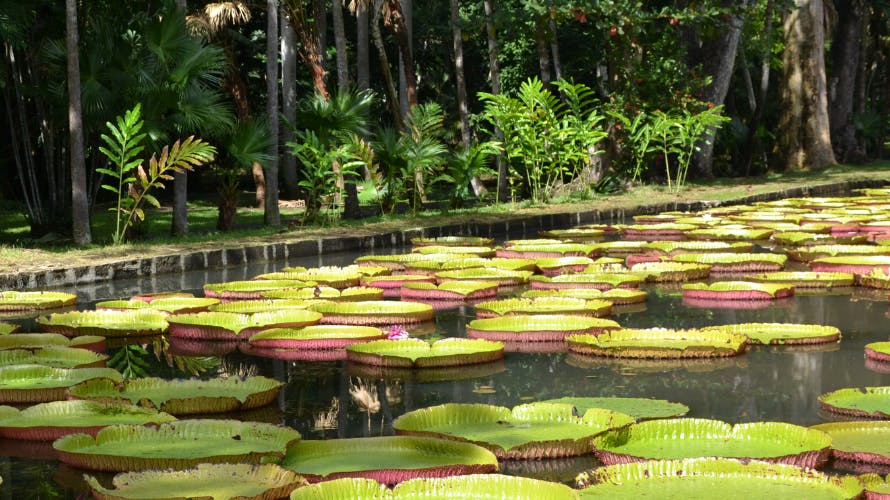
[0,242,890,500]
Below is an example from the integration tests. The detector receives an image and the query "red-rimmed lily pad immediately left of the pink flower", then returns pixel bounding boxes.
[249,325,386,350]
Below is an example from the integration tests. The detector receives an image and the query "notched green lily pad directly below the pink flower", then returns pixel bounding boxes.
[346,338,504,368]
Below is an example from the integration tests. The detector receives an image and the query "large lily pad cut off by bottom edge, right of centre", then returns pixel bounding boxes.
[577,458,862,500]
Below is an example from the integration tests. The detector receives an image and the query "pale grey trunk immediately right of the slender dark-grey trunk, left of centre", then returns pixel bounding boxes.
[280,12,299,200]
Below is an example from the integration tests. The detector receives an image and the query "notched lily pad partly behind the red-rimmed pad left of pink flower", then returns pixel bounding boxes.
[168,309,322,340]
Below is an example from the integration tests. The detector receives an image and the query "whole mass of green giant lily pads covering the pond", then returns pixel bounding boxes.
[8,190,890,499]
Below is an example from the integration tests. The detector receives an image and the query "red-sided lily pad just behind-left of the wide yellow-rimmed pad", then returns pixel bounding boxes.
[474,297,612,318]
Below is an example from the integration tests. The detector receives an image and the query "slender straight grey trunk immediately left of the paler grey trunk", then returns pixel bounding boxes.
[263,0,281,226]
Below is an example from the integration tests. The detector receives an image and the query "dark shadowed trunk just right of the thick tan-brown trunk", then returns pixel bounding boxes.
[828,0,867,162]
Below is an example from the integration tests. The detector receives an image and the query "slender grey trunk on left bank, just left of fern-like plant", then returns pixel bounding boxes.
[65,0,93,246]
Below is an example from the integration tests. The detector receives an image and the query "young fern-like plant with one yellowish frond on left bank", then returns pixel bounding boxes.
[97,104,216,245]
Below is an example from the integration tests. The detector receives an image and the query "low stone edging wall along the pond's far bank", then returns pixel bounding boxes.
[0,179,890,290]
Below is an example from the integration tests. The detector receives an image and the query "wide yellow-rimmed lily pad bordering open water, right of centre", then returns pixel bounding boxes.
[566,328,748,358]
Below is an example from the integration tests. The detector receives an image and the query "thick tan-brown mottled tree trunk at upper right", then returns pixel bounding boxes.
[778,0,835,170]
